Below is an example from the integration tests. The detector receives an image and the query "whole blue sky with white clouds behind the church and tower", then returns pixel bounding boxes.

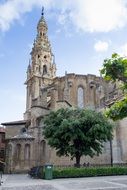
[0,0,127,123]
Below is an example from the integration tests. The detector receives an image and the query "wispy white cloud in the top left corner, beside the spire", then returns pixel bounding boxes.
[0,0,52,31]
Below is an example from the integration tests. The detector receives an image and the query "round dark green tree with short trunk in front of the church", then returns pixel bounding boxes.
[43,109,113,166]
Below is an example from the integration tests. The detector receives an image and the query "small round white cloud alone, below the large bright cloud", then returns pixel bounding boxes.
[94,41,109,52]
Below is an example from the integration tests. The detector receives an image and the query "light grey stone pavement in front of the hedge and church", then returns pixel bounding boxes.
[0,174,127,190]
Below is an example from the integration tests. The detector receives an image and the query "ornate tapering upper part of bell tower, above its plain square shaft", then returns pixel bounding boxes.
[31,8,56,80]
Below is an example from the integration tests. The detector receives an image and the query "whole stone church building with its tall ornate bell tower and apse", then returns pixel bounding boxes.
[2,8,127,172]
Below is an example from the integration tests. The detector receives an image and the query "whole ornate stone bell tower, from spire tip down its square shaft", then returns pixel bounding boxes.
[25,8,56,119]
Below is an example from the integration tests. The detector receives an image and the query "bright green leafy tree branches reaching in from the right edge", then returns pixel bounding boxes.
[100,53,127,120]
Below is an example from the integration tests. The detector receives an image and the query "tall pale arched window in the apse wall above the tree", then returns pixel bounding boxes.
[77,87,84,108]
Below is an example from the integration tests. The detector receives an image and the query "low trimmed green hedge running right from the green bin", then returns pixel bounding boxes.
[53,167,127,179]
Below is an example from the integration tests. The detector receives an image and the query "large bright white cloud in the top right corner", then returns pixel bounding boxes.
[72,0,127,32]
